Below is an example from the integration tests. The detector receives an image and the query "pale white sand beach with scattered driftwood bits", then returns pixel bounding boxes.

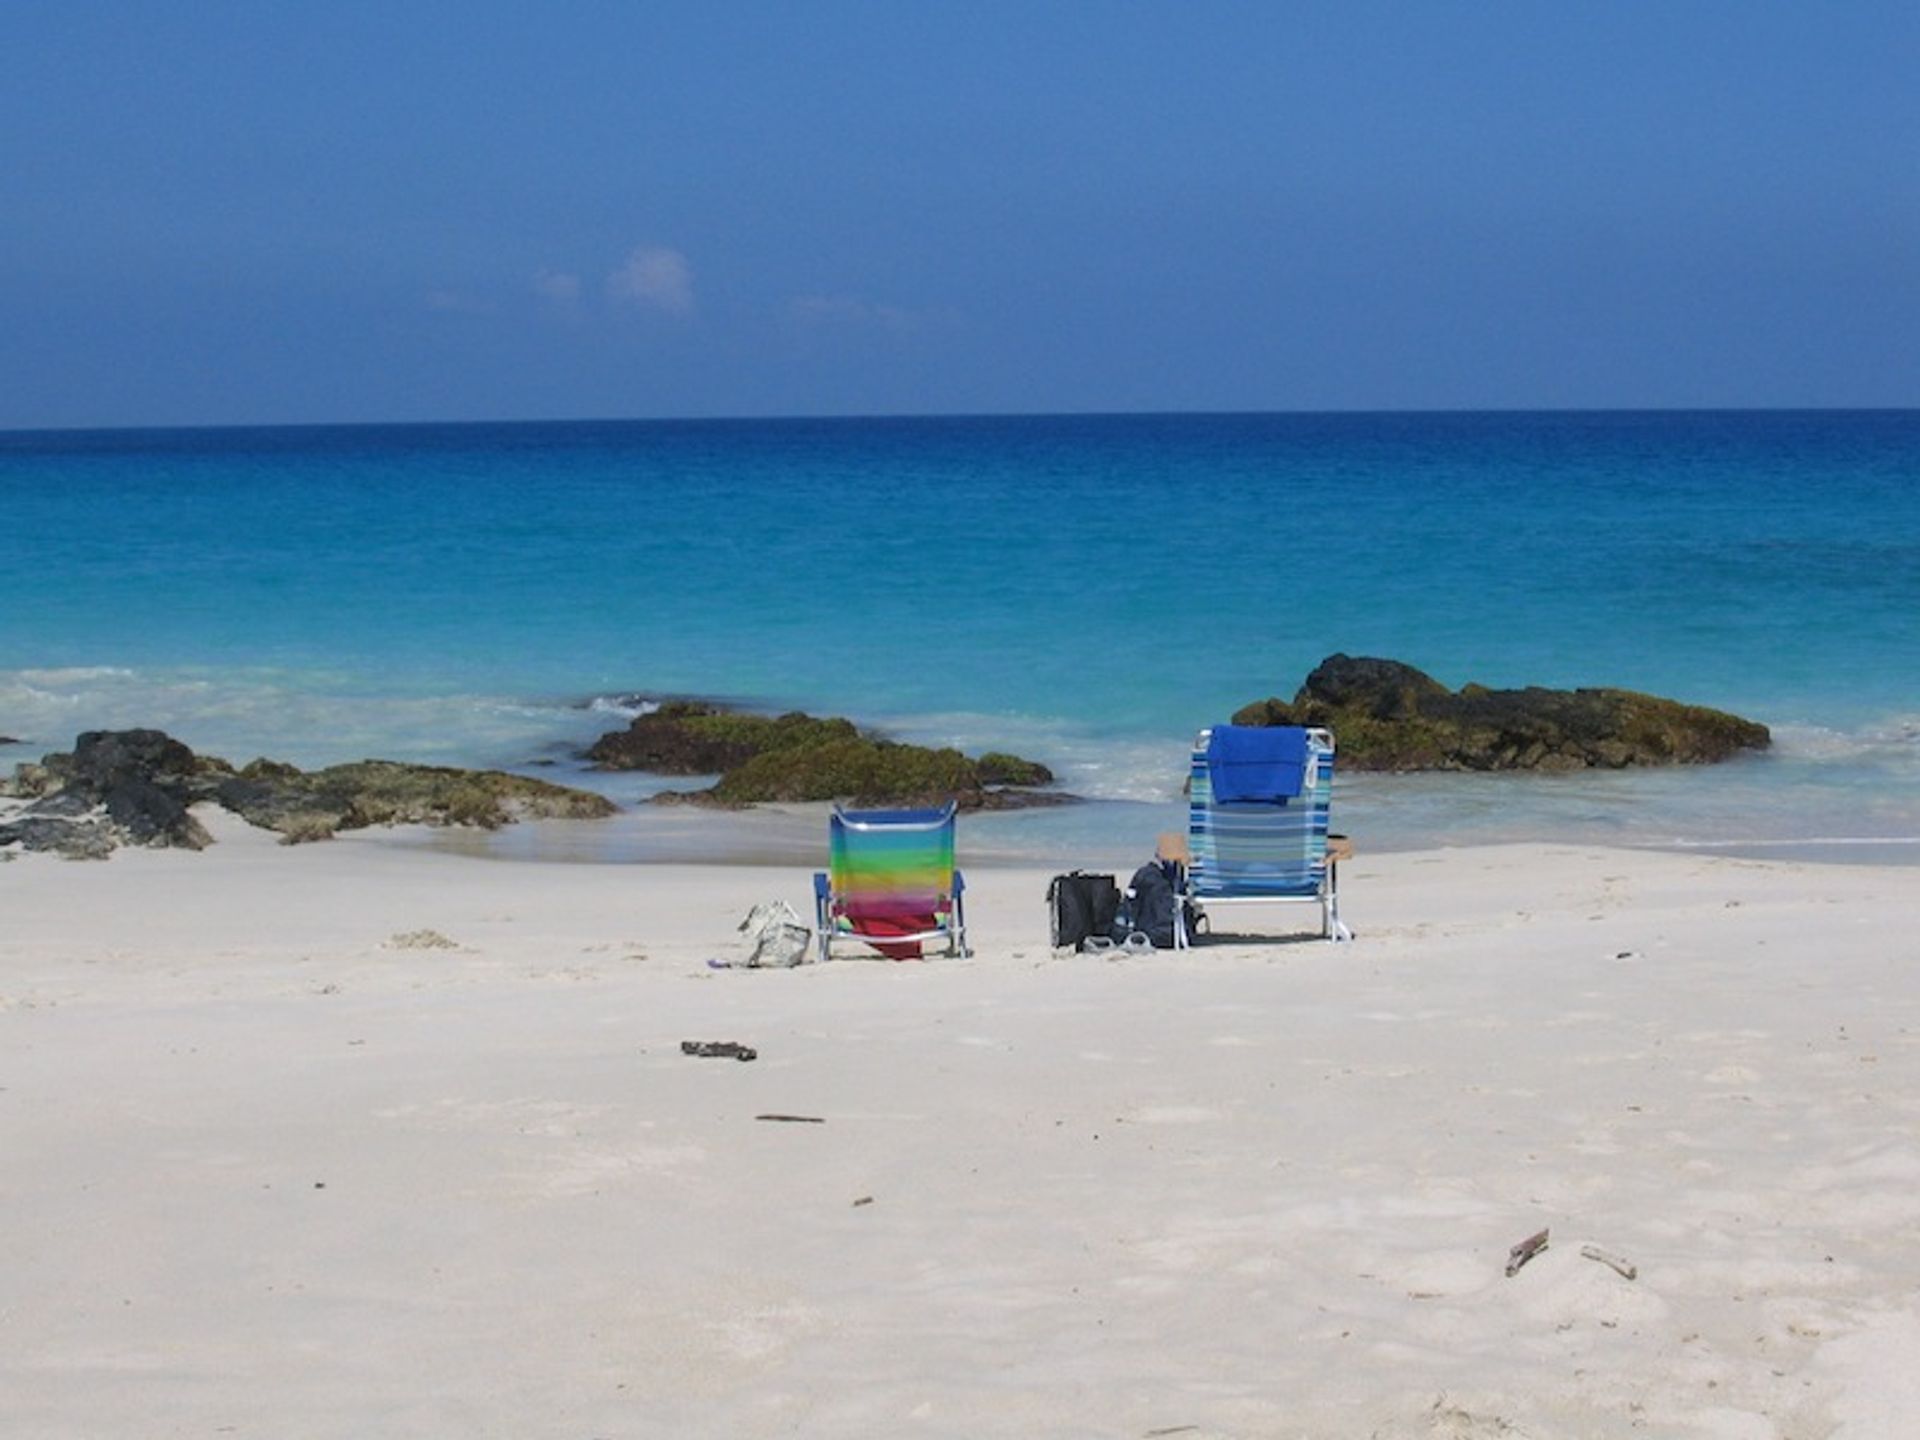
[0,814,1920,1440]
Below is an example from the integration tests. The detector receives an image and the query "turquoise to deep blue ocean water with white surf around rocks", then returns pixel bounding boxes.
[0,411,1920,864]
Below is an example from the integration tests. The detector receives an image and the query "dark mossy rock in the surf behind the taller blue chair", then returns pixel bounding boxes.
[1233,655,1772,770]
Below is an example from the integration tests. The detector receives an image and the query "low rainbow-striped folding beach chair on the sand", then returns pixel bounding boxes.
[814,803,968,960]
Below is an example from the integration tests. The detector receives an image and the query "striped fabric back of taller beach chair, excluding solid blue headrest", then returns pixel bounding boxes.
[1187,728,1332,900]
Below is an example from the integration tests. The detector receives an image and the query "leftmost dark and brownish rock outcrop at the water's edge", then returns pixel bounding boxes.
[0,730,616,858]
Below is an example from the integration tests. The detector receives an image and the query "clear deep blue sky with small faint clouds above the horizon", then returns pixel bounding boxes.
[0,0,1920,428]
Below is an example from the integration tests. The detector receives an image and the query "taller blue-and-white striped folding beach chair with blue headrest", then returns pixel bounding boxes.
[1175,726,1354,943]
